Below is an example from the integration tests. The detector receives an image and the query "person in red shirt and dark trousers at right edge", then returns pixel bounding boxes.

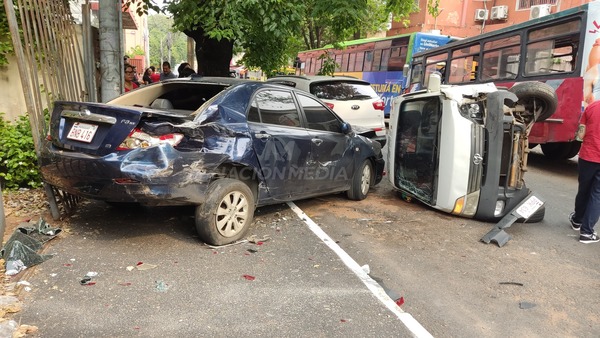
[569,101,600,243]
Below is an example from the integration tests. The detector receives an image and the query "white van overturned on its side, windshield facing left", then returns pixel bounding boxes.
[388,74,557,222]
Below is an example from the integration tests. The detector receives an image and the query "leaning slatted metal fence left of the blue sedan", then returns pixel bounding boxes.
[4,0,90,223]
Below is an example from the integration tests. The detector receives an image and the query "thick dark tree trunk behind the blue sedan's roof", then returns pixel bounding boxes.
[184,29,233,77]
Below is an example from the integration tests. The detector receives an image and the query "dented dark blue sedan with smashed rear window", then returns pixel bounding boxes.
[41,77,384,245]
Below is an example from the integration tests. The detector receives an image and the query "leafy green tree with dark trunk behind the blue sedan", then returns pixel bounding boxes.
[126,0,415,76]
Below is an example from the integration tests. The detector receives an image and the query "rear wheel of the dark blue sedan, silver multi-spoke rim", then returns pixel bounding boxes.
[196,178,254,245]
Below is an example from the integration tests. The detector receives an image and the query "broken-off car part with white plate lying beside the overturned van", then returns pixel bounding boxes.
[481,193,544,247]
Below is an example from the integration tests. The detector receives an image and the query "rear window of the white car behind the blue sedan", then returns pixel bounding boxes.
[310,81,378,101]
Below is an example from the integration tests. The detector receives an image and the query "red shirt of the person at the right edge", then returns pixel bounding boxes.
[579,100,600,163]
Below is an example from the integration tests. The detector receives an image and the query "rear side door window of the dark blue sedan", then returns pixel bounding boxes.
[248,90,300,127]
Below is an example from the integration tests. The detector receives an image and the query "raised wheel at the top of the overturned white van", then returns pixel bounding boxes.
[509,81,558,122]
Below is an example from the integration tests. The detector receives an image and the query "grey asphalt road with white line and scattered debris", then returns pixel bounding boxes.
[9,147,600,337]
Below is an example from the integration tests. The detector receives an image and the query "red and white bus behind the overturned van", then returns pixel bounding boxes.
[409,2,600,159]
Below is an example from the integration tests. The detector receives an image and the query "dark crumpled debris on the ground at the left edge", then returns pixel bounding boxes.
[0,218,61,276]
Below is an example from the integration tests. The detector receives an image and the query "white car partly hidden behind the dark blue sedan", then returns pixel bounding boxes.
[267,75,386,146]
